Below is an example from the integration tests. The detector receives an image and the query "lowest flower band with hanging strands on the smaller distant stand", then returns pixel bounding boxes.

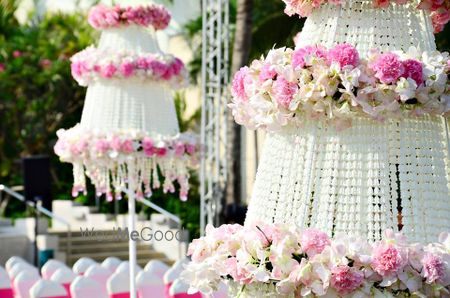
[54,125,200,201]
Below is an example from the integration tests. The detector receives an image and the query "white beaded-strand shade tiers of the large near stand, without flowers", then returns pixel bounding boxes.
[246,1,450,242]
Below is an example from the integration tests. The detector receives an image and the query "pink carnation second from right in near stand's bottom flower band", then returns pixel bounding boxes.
[372,243,406,277]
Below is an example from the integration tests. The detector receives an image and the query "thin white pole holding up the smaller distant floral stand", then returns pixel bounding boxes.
[128,160,136,298]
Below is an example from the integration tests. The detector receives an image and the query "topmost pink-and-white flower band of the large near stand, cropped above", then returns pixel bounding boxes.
[282,0,450,33]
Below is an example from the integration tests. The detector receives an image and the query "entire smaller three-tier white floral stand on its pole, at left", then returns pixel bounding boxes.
[55,4,199,298]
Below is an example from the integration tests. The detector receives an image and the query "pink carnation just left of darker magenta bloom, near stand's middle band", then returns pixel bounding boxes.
[370,53,405,84]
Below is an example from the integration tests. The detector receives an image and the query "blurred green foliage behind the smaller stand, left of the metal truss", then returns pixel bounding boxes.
[0,0,200,236]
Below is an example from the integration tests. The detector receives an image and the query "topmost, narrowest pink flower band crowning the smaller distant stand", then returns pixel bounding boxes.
[88,4,171,30]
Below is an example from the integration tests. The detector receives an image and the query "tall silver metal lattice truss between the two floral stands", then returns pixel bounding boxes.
[200,0,230,234]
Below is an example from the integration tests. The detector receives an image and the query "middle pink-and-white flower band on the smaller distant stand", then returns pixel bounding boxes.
[70,46,188,88]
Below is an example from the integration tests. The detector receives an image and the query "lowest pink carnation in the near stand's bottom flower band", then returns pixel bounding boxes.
[331,265,364,295]
